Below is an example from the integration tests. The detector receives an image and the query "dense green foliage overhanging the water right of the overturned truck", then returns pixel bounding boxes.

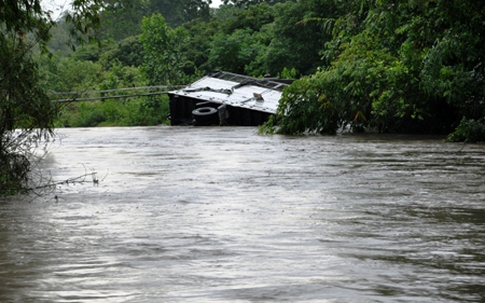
[267,0,485,141]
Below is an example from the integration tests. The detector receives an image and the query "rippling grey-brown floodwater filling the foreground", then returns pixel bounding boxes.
[0,126,485,303]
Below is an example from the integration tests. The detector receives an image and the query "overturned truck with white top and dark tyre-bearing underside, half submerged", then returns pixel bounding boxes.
[168,71,291,126]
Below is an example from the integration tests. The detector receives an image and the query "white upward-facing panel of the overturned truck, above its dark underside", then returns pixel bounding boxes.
[170,72,288,114]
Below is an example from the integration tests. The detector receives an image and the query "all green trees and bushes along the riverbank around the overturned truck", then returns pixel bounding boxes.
[0,0,485,195]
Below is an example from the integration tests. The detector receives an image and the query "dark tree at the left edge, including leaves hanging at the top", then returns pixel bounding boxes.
[0,0,104,195]
